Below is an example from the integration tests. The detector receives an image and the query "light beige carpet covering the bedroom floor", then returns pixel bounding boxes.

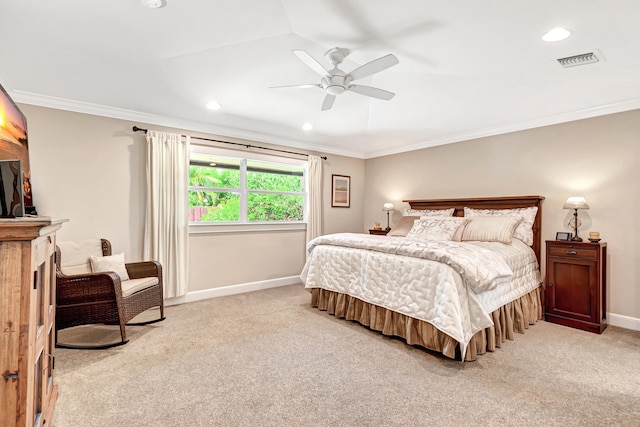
[53,285,640,427]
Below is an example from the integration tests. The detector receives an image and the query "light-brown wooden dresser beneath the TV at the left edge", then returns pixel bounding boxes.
[0,217,66,427]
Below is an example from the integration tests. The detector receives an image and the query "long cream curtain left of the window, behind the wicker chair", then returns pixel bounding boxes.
[144,130,190,298]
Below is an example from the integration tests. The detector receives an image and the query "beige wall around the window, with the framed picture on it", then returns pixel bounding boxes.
[20,105,364,292]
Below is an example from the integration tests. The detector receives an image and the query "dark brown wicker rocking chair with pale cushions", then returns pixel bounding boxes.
[55,239,165,349]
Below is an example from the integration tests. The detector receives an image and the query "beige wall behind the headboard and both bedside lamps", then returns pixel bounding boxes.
[364,110,640,323]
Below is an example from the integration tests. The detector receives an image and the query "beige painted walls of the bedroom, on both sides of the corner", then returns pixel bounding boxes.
[20,105,640,328]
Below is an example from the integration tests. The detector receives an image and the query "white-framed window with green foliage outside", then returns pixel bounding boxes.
[189,146,307,225]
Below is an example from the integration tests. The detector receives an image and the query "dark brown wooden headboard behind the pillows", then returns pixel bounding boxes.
[403,196,544,265]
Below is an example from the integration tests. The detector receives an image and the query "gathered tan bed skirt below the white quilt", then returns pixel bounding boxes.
[310,287,543,361]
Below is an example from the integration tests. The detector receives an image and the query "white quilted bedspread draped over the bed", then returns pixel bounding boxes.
[301,233,540,354]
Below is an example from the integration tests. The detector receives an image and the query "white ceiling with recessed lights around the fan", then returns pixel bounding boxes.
[0,0,640,158]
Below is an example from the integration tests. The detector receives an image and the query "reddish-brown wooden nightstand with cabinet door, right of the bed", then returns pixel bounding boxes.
[545,240,607,334]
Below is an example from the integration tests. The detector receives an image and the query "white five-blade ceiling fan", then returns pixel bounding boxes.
[274,47,400,111]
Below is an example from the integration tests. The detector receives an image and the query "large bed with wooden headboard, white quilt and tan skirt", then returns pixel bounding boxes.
[301,196,544,361]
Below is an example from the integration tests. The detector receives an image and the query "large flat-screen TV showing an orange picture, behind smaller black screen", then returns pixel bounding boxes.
[0,81,33,206]
